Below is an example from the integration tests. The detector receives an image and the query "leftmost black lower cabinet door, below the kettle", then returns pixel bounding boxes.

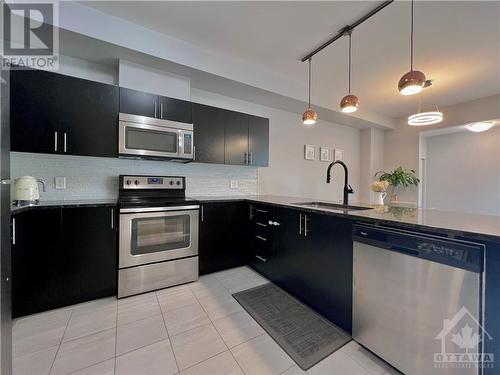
[12,208,64,317]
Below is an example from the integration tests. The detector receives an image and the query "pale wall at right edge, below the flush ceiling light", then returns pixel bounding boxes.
[426,126,500,215]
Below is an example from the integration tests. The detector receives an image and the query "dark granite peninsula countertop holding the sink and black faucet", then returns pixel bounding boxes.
[191,195,500,242]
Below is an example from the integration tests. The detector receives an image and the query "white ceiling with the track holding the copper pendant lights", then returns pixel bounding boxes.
[84,1,500,117]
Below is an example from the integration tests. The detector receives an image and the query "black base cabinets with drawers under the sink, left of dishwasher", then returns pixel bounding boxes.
[248,205,352,333]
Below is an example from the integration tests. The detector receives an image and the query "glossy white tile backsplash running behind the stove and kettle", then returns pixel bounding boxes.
[11,152,258,201]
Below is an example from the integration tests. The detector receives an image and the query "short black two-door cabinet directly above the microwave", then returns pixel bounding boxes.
[120,87,193,124]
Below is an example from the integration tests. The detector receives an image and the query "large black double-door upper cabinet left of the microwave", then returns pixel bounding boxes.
[11,70,119,157]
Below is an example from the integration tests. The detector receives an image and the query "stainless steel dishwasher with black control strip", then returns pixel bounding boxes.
[353,224,484,375]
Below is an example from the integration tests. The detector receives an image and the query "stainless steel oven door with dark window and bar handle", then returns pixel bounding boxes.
[119,206,199,268]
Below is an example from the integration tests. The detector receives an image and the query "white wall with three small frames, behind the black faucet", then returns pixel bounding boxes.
[191,88,360,201]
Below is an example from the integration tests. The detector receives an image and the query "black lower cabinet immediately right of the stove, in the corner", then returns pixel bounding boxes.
[198,202,248,275]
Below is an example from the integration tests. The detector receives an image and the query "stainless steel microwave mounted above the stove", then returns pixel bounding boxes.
[118,113,194,162]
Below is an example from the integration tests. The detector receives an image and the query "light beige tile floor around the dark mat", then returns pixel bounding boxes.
[13,267,398,375]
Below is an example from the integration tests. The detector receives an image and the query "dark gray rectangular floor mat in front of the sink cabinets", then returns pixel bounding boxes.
[233,283,351,370]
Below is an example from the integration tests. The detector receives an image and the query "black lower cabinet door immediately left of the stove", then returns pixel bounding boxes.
[62,207,118,304]
